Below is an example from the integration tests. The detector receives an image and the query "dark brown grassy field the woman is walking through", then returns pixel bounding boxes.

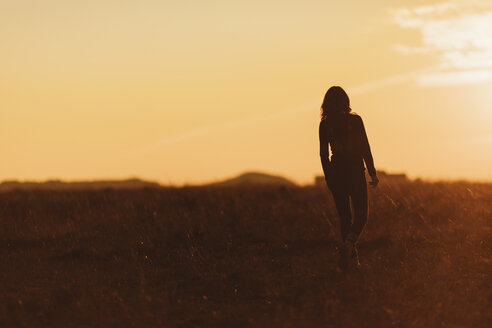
[0,181,492,327]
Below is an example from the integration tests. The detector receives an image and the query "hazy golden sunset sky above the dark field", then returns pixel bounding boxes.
[0,0,492,185]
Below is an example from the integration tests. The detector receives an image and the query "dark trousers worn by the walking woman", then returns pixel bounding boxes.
[330,165,368,242]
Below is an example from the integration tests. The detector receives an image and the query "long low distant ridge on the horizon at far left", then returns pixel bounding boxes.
[0,179,160,191]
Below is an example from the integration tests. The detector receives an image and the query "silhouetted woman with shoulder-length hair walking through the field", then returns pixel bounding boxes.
[319,86,379,268]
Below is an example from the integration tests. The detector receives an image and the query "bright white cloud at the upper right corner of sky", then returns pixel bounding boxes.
[391,0,492,86]
